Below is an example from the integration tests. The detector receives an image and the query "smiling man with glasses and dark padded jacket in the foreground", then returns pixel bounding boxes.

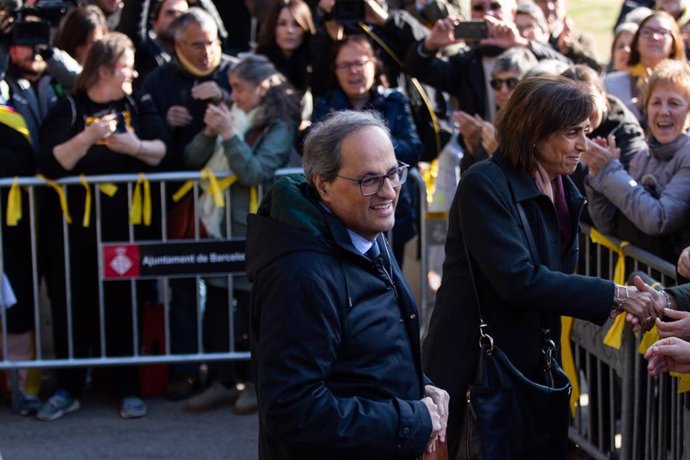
[247,111,448,460]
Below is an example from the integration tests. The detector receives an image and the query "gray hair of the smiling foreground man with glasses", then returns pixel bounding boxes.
[302,110,390,184]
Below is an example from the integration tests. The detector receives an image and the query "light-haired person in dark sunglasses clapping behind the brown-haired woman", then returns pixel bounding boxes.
[453,48,537,171]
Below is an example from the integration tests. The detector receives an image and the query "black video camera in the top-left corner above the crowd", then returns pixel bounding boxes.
[0,0,72,46]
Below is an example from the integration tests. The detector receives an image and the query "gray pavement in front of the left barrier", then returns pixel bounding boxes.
[0,392,258,460]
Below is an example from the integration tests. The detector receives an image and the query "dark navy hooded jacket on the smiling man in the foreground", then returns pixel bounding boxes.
[247,176,431,460]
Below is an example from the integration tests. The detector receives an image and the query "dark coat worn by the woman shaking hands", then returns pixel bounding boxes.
[423,152,614,458]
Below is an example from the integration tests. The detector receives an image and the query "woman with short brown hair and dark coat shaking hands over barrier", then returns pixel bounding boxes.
[423,77,657,459]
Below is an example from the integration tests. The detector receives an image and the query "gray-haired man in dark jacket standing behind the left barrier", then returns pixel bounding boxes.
[143,7,237,400]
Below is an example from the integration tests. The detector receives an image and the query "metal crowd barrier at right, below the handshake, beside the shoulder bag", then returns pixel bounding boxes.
[569,226,690,460]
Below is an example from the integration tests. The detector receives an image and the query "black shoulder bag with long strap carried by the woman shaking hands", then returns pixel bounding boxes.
[463,202,572,460]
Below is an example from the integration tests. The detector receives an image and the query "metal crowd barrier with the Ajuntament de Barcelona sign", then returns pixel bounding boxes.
[0,168,429,398]
